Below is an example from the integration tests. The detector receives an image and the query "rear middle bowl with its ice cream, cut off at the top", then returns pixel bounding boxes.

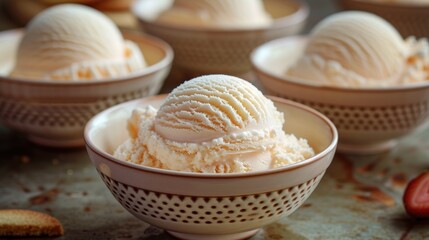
[133,0,309,76]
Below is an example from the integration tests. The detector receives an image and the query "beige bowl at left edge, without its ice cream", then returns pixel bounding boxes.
[0,30,173,147]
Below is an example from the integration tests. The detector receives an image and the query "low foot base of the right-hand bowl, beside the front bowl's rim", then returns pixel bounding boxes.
[337,140,398,155]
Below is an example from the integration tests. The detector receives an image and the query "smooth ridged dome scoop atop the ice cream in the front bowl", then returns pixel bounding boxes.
[155,75,283,142]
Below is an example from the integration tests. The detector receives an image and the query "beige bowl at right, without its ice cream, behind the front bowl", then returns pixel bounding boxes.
[251,36,429,154]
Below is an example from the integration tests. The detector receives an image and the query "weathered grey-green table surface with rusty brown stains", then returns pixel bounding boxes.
[0,0,429,240]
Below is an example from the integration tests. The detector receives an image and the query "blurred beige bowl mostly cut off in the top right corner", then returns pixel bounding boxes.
[338,0,429,37]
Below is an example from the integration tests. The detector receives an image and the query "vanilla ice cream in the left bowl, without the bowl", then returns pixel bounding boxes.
[11,4,146,80]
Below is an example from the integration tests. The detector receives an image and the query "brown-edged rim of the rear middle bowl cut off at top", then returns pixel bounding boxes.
[131,0,310,34]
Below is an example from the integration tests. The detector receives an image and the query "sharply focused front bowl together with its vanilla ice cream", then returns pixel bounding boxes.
[85,75,337,239]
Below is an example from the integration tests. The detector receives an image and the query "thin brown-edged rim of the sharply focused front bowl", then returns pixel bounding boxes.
[84,94,338,178]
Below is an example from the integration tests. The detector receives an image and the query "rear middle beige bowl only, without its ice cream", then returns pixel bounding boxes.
[133,0,309,76]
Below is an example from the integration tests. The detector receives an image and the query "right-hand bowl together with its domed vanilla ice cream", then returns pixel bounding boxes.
[252,12,429,154]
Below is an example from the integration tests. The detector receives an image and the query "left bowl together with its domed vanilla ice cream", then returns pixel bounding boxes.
[0,5,173,147]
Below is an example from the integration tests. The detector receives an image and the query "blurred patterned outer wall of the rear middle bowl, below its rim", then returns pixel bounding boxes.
[148,27,268,73]
